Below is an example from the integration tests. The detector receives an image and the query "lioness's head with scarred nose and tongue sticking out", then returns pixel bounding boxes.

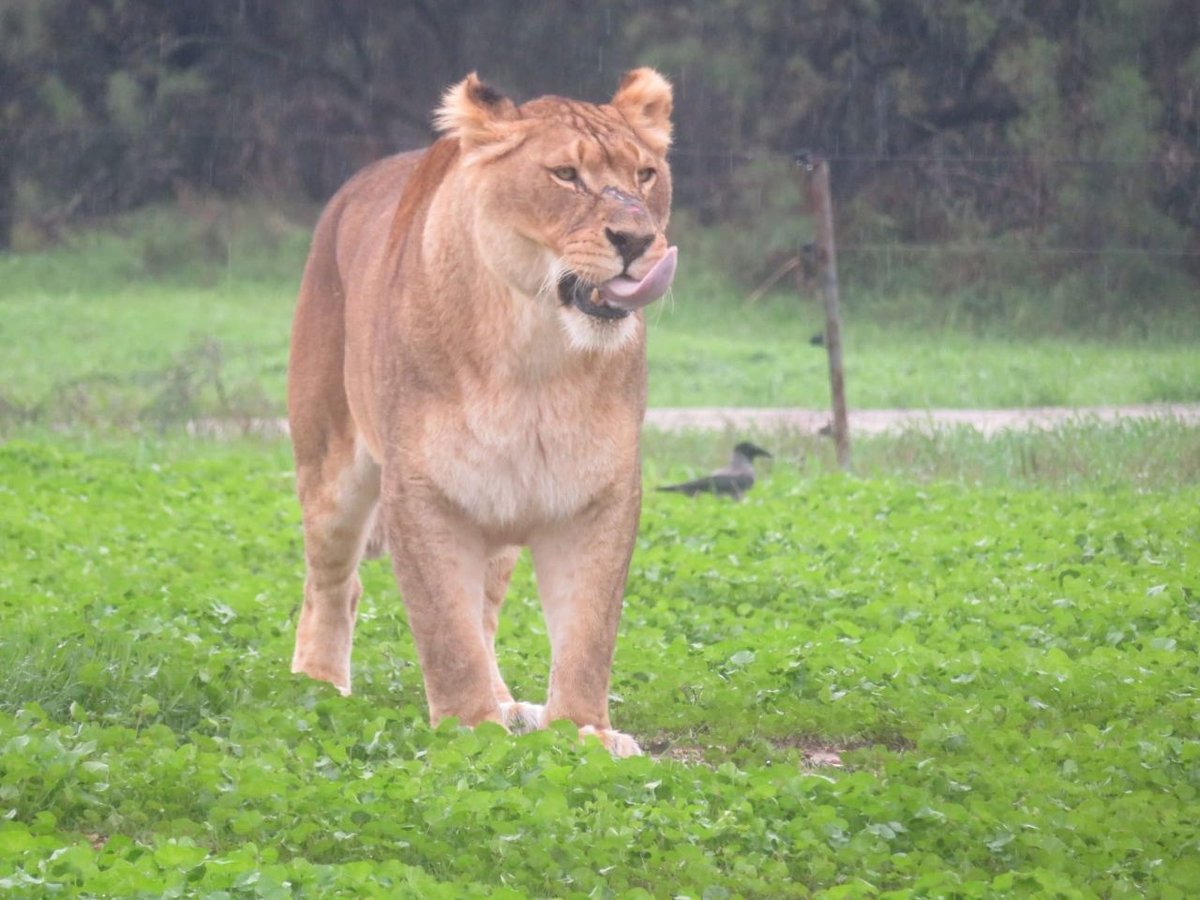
[436,68,676,346]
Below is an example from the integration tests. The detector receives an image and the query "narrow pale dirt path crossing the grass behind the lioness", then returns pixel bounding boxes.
[187,403,1200,437]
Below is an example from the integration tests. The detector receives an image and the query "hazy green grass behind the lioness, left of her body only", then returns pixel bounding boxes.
[0,209,307,426]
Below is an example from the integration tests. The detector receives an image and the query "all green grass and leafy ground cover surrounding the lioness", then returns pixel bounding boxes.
[0,208,1200,898]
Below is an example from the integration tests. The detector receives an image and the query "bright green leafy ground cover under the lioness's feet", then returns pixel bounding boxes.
[0,438,1200,898]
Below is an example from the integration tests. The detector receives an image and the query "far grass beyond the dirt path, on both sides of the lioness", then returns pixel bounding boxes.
[0,208,1200,430]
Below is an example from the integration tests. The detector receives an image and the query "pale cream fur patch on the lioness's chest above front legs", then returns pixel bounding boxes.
[425,391,636,533]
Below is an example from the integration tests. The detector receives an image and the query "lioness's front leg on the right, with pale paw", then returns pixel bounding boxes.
[529,486,641,756]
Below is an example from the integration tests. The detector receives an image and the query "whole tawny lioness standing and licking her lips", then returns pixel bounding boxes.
[288,68,676,756]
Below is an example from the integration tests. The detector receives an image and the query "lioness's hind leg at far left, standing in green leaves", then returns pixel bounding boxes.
[292,442,379,695]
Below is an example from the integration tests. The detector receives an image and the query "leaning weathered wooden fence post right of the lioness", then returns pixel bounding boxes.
[796,150,850,472]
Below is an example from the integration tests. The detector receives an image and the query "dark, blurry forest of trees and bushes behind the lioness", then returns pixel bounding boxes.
[0,0,1200,302]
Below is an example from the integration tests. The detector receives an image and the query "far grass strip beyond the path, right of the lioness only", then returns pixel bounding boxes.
[649,312,1200,409]
